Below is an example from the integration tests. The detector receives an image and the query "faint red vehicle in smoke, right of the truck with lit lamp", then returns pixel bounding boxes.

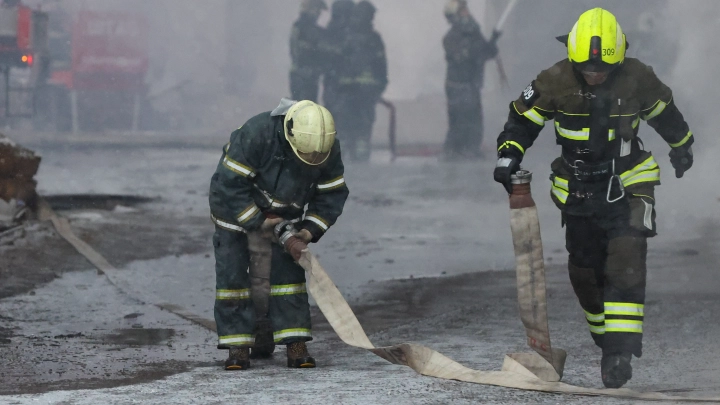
[48,11,149,132]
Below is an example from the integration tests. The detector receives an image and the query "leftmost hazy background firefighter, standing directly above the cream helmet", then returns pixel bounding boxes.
[290,0,327,102]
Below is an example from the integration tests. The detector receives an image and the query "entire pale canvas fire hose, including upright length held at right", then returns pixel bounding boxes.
[38,197,720,403]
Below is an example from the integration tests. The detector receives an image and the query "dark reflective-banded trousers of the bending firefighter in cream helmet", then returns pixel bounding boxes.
[213,226,312,349]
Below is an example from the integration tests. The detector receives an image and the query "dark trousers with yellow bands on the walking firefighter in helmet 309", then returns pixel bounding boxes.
[563,196,655,357]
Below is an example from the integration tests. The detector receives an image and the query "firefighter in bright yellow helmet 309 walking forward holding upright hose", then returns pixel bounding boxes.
[494,8,694,388]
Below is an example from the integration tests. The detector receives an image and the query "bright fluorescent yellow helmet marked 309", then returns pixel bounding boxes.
[567,8,627,68]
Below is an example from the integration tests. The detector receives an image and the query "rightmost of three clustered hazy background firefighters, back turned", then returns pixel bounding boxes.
[333,1,388,162]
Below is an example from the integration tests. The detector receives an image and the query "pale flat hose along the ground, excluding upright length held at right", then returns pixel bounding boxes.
[40,202,720,403]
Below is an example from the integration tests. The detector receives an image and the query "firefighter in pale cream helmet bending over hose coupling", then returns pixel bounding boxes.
[209,99,348,370]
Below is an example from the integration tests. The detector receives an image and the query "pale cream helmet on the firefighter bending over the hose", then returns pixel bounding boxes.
[284,100,335,166]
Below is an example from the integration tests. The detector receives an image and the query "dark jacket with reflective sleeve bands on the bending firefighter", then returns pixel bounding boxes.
[209,107,348,241]
